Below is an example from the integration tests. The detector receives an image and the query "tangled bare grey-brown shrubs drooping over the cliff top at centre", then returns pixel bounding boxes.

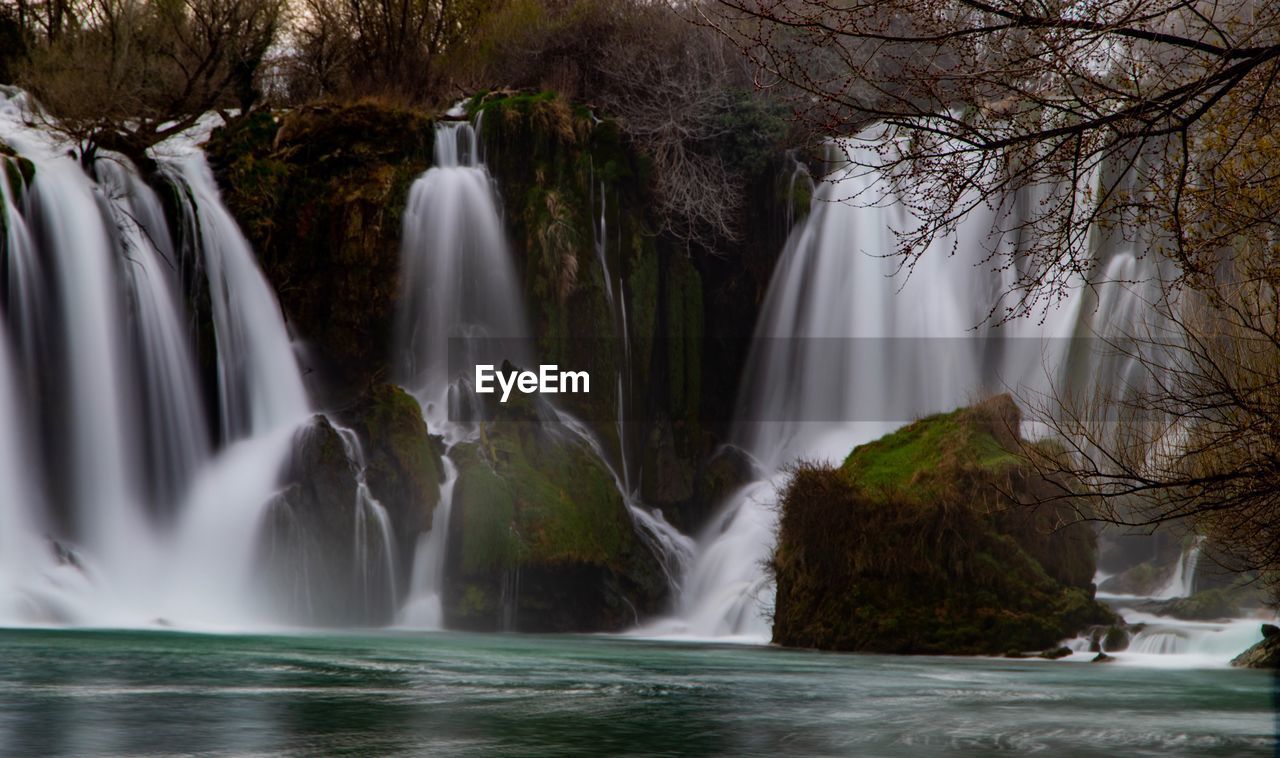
[472,0,787,250]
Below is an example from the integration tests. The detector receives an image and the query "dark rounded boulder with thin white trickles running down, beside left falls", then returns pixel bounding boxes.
[260,384,440,626]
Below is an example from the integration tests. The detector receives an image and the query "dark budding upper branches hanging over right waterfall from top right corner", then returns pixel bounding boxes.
[696,0,1280,311]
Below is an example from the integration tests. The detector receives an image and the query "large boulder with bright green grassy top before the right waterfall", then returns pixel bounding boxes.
[772,397,1115,654]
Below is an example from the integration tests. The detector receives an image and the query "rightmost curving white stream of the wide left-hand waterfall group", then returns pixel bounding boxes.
[163,142,310,624]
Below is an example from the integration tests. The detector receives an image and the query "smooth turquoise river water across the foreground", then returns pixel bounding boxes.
[0,630,1280,757]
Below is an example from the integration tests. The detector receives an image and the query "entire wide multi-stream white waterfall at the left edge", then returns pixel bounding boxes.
[0,90,310,626]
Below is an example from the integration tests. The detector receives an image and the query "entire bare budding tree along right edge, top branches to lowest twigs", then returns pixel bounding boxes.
[685,0,1280,586]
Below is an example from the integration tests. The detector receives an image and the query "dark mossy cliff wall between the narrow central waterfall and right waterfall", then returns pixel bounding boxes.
[471,92,795,531]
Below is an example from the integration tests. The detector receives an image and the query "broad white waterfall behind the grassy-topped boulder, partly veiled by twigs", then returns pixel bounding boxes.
[654,137,1153,640]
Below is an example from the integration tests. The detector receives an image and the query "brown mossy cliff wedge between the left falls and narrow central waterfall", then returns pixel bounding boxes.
[207,101,434,402]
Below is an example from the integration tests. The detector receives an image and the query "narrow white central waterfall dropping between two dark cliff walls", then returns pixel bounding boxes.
[396,122,530,629]
